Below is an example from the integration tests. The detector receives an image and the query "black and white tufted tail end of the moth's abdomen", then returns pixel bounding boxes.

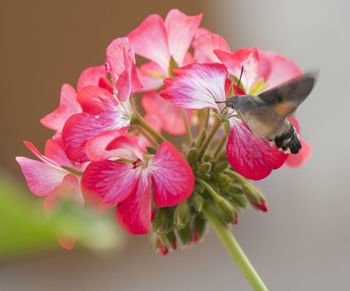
[274,123,301,154]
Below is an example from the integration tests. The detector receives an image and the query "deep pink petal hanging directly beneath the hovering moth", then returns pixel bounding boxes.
[226,119,288,180]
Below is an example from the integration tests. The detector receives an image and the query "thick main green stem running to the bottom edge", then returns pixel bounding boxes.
[203,203,268,291]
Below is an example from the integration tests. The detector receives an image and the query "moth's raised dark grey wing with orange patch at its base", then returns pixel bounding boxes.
[258,72,318,118]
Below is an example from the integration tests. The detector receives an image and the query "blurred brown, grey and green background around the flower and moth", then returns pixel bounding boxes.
[0,0,350,291]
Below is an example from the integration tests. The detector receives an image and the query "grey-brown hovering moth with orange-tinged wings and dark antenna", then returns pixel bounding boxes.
[222,67,318,154]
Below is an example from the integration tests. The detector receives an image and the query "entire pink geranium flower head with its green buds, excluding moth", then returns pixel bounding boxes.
[17,9,311,254]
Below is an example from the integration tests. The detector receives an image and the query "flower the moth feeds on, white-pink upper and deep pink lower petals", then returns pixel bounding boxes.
[161,64,287,180]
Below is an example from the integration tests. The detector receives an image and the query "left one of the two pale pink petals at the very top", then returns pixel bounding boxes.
[128,14,170,72]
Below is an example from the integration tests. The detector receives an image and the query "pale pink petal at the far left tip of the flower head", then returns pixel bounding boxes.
[16,157,68,196]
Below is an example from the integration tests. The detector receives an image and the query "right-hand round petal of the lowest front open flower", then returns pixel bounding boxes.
[148,142,194,207]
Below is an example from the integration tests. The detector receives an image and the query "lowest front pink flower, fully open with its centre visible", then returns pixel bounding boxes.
[82,138,194,234]
